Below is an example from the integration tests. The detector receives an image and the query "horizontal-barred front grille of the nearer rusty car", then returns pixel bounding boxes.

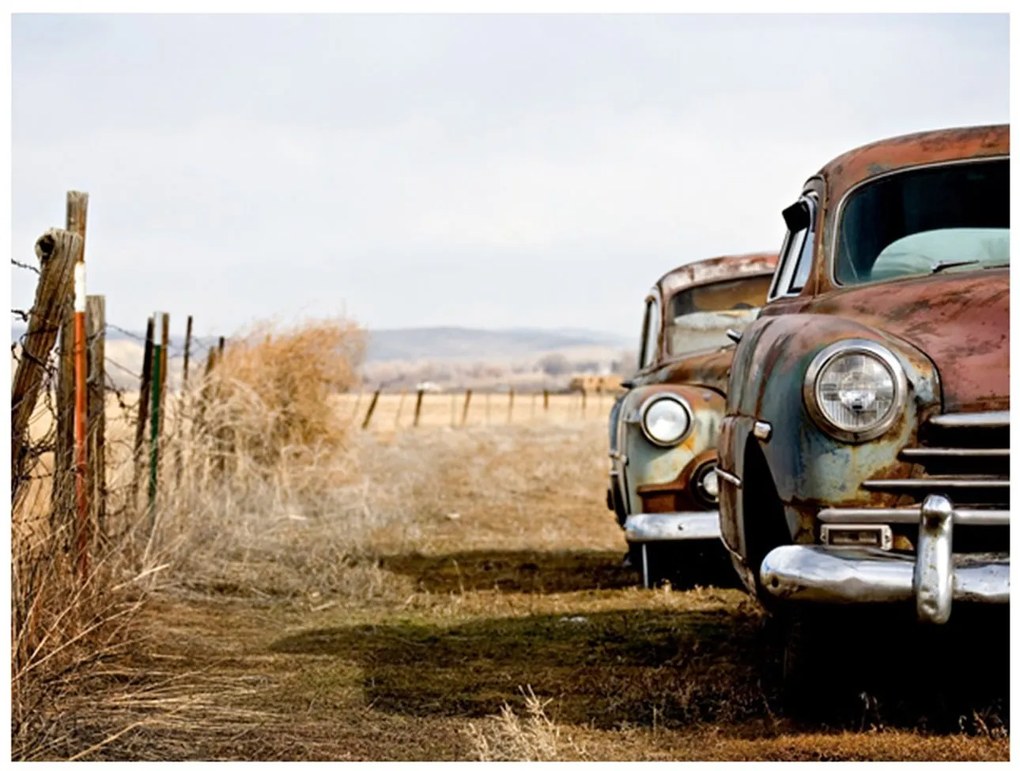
[864,412,1010,510]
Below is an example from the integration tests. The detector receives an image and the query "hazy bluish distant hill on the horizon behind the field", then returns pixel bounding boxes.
[365,326,635,362]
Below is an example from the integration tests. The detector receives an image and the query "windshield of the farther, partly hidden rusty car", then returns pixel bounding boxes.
[665,274,772,356]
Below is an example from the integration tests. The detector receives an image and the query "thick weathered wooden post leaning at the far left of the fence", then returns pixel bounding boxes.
[10,229,84,505]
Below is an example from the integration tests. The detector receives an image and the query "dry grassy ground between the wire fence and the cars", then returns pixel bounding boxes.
[19,416,1009,760]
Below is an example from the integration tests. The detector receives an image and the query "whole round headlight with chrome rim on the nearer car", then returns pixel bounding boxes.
[805,340,906,442]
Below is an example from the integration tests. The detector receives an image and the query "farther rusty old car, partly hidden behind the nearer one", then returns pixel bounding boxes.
[607,253,776,586]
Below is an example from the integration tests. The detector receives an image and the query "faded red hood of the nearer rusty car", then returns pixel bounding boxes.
[810,268,1010,412]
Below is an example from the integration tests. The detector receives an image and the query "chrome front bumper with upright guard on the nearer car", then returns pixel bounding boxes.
[761,496,1010,624]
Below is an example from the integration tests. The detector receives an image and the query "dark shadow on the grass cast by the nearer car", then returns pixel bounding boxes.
[271,591,1009,736]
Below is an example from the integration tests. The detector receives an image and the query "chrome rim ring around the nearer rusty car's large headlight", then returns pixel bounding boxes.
[804,340,907,443]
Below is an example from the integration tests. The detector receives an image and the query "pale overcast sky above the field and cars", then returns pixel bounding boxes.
[11,14,1009,337]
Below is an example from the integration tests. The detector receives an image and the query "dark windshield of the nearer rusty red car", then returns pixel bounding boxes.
[835,159,1010,285]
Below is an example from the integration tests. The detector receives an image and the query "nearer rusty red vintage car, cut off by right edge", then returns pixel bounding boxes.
[717,125,1010,705]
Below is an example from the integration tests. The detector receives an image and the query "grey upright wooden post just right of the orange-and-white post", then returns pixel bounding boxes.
[86,295,107,537]
